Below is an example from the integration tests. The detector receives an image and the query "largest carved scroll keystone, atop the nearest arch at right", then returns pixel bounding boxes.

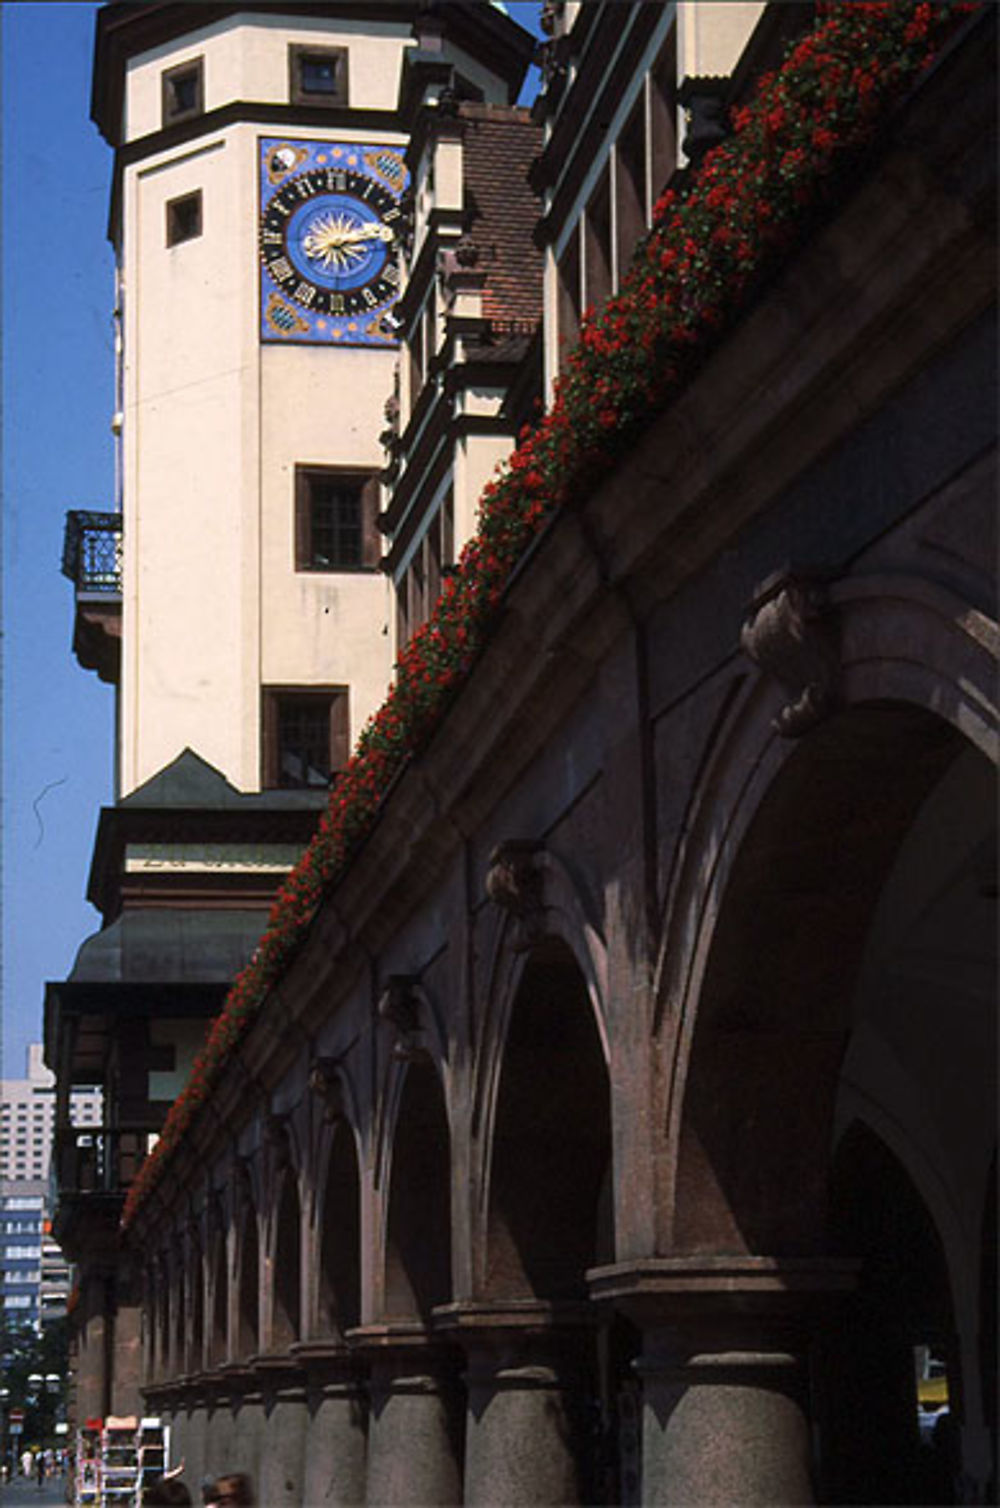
[739,572,840,739]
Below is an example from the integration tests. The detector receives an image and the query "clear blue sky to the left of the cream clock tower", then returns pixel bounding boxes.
[0,0,115,1077]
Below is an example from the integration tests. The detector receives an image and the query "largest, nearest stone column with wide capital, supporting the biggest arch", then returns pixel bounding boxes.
[588,1258,855,1508]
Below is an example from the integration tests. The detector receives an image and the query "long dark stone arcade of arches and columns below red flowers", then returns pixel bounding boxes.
[49,2,1000,1508]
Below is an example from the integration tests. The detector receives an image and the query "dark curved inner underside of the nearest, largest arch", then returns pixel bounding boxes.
[664,704,962,1255]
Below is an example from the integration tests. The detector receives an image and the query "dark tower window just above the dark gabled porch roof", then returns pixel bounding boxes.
[262,686,350,790]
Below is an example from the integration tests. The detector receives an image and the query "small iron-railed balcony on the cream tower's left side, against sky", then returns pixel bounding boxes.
[62,510,122,685]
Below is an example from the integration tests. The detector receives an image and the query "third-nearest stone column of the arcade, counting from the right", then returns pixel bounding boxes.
[355,1326,462,1508]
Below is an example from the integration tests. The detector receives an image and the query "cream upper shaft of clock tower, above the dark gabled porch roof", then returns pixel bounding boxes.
[92,0,529,796]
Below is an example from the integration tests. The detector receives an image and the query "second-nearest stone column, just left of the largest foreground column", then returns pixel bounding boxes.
[434,1300,596,1508]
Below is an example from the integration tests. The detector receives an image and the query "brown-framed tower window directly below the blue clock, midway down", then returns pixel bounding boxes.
[296,466,380,570]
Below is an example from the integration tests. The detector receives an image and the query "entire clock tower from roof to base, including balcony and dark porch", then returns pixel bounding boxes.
[45,0,534,1429]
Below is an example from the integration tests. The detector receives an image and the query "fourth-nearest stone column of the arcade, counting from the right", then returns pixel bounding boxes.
[293,1339,368,1508]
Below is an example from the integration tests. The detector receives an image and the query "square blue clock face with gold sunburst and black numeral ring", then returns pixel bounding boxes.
[258,139,407,345]
